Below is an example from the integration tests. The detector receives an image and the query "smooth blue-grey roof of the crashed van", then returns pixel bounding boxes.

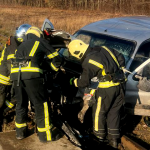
[81,16,150,45]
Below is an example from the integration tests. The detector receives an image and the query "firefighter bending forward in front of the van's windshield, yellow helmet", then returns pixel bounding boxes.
[68,39,125,148]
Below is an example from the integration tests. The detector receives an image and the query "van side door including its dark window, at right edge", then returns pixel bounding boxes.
[125,42,150,116]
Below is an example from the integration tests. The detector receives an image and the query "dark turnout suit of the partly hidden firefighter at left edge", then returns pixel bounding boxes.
[0,36,19,123]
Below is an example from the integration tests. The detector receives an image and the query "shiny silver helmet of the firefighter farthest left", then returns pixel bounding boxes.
[15,24,31,42]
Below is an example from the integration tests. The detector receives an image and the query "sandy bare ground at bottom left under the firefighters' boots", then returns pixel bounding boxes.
[0,131,80,150]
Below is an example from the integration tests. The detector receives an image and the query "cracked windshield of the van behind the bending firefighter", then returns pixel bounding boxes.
[60,30,135,63]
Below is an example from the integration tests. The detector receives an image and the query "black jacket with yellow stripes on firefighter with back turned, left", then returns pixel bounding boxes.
[11,34,61,80]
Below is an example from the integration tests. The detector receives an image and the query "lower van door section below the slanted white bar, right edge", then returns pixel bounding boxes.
[125,58,150,116]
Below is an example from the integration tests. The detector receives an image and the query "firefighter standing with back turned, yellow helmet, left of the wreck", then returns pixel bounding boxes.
[11,27,61,142]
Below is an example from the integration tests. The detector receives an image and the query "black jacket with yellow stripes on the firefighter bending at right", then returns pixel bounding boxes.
[74,46,125,88]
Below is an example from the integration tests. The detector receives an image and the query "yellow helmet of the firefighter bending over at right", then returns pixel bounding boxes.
[68,39,89,59]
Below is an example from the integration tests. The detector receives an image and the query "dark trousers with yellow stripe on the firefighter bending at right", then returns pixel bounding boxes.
[92,86,124,139]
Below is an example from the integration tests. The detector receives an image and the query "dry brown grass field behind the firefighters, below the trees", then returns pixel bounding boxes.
[0,5,124,49]
